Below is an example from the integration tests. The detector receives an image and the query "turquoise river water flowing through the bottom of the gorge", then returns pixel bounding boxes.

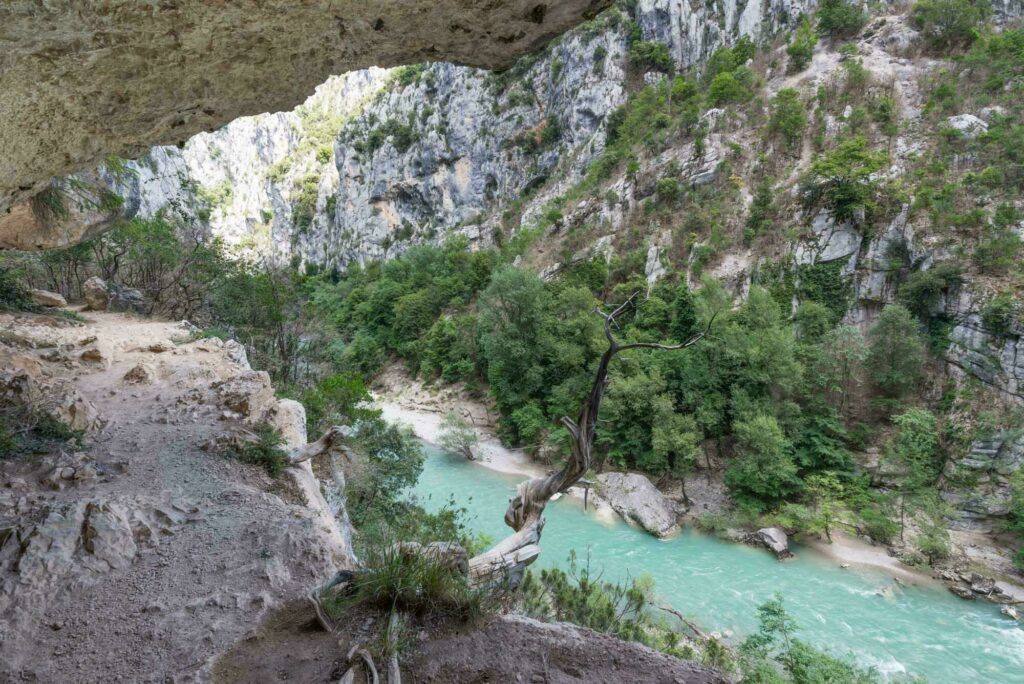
[415,445,1024,684]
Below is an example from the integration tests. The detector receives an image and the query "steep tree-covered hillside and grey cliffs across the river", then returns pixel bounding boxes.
[8,0,1024,626]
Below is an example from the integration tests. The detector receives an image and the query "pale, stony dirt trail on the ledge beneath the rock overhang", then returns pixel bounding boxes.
[0,313,348,682]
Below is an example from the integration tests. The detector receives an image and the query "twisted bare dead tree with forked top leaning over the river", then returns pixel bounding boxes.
[469,292,714,586]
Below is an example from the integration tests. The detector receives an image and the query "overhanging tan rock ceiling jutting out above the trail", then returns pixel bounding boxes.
[0,0,610,233]
